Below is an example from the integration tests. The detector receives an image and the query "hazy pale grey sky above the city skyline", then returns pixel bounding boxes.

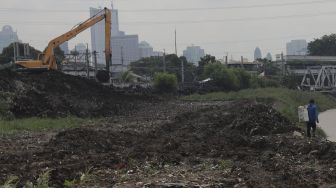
[0,0,336,59]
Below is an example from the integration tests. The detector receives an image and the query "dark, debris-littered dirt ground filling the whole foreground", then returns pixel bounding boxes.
[0,100,336,188]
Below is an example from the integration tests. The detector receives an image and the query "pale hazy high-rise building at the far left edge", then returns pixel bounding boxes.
[0,25,19,53]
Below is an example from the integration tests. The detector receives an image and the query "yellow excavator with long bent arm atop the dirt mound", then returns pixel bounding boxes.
[15,8,112,71]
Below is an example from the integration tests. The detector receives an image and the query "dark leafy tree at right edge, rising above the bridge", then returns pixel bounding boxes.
[308,34,336,56]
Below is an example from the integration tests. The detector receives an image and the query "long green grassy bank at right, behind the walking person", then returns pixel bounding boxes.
[182,88,336,122]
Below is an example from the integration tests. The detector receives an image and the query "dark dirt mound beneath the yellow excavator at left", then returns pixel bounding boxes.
[0,71,147,117]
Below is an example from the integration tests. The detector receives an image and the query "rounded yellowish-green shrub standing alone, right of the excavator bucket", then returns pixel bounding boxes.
[154,73,177,93]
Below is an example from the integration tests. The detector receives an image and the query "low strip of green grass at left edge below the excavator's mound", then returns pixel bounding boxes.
[0,117,89,134]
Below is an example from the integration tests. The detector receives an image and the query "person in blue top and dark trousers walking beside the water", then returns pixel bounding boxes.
[307,99,319,138]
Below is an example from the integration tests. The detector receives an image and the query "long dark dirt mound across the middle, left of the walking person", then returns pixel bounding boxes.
[48,101,297,164]
